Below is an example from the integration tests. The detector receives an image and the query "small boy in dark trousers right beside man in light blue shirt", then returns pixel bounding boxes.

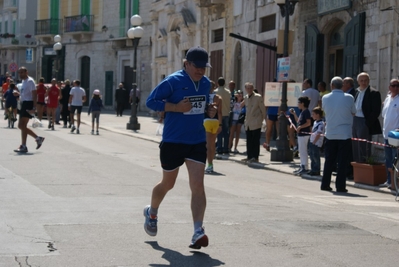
[309,107,324,176]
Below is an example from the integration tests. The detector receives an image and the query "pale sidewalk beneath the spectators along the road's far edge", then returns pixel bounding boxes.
[81,107,394,197]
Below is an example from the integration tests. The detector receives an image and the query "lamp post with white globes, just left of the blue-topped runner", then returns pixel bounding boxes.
[126,15,144,131]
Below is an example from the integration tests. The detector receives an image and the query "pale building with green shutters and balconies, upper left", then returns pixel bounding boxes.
[35,0,151,108]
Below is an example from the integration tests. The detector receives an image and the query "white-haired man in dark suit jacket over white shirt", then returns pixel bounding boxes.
[352,72,382,162]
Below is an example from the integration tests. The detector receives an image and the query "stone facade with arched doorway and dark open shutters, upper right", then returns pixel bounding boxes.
[291,0,399,100]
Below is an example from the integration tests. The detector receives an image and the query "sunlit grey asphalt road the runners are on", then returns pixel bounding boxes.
[0,121,399,267]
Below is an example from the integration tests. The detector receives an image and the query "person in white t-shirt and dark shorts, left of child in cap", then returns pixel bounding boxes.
[68,80,86,134]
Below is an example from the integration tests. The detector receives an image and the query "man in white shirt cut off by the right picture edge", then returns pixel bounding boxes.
[380,79,399,188]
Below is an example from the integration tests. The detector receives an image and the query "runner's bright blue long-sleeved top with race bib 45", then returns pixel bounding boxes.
[146,70,211,144]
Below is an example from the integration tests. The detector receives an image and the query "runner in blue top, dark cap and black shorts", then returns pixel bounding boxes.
[144,47,210,249]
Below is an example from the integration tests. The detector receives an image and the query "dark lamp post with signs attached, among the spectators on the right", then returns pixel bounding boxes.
[270,0,298,161]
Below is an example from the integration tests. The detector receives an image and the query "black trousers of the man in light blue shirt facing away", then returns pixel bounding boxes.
[321,138,351,189]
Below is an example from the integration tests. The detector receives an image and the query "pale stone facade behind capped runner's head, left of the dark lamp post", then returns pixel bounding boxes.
[151,0,295,96]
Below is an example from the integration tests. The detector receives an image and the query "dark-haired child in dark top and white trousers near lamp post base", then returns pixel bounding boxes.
[290,96,312,175]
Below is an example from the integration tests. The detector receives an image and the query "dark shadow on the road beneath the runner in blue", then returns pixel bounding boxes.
[145,241,225,267]
